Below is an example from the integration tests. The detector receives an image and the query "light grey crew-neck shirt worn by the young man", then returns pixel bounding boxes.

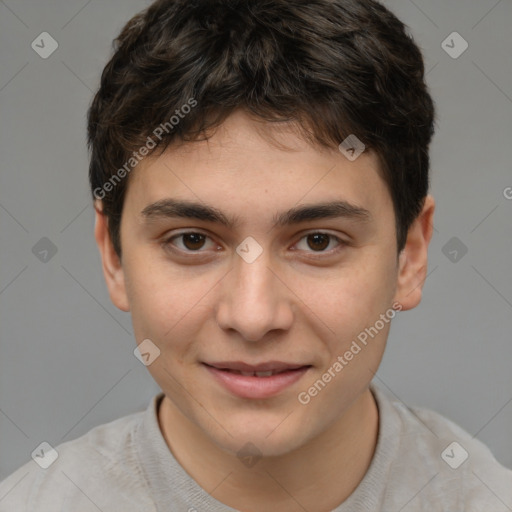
[0,383,512,512]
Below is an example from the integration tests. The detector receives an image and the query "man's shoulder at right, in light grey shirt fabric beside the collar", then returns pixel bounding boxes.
[377,390,512,512]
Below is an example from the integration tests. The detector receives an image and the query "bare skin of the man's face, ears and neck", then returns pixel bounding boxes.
[95,111,435,512]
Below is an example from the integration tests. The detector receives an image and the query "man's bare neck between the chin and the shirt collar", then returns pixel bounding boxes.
[158,389,379,512]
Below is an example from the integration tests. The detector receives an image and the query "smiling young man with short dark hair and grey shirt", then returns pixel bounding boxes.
[0,0,512,512]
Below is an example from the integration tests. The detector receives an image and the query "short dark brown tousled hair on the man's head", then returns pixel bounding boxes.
[88,0,435,256]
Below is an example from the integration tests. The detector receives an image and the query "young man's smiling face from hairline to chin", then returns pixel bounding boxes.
[97,112,428,455]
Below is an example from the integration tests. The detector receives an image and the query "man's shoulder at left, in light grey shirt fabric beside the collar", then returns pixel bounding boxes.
[0,406,154,512]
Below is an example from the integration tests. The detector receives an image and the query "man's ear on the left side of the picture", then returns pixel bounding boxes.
[94,201,130,311]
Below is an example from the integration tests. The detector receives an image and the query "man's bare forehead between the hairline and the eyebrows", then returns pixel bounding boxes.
[126,113,391,224]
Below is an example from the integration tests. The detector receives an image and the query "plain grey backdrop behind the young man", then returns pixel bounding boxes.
[0,0,512,480]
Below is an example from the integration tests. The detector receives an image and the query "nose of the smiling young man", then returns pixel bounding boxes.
[216,251,293,342]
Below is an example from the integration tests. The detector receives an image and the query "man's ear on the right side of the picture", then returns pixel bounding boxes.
[395,195,435,311]
